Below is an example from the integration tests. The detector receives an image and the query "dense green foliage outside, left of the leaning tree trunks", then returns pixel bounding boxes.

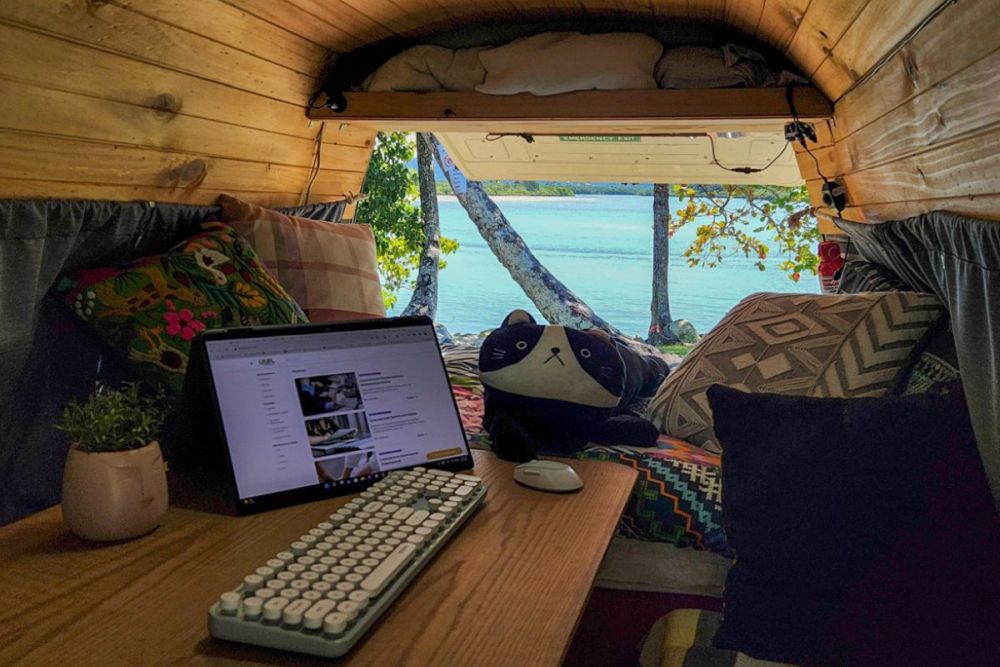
[355,132,458,308]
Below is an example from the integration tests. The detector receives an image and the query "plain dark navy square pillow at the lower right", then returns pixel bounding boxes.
[708,385,1000,665]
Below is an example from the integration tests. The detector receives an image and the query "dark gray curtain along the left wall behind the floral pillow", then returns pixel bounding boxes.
[0,200,345,525]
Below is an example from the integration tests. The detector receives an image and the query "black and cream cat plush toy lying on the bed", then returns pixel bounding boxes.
[479,310,670,461]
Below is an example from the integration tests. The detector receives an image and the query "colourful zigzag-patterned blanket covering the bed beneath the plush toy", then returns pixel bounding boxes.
[442,345,732,557]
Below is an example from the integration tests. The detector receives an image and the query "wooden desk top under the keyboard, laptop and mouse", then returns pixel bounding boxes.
[0,452,635,667]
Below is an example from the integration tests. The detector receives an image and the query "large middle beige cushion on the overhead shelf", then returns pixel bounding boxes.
[476,32,663,95]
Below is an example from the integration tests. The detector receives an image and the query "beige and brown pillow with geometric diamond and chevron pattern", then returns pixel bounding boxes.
[646,292,945,452]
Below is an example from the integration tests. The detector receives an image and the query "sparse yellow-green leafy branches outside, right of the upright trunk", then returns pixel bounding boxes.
[670,185,821,282]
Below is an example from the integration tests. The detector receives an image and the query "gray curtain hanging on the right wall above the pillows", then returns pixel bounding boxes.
[836,212,1000,508]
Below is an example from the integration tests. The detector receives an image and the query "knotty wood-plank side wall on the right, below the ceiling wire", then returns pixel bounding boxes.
[797,0,1000,221]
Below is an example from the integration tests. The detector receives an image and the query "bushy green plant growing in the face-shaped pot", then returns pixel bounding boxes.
[55,382,165,452]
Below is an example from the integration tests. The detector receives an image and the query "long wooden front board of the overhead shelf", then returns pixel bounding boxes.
[309,86,833,134]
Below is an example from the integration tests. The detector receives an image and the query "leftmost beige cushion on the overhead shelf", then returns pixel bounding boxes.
[364,46,486,92]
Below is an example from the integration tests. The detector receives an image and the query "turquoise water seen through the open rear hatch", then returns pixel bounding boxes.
[390,195,819,336]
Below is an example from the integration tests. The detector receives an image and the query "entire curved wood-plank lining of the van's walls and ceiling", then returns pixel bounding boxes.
[0,0,1000,227]
